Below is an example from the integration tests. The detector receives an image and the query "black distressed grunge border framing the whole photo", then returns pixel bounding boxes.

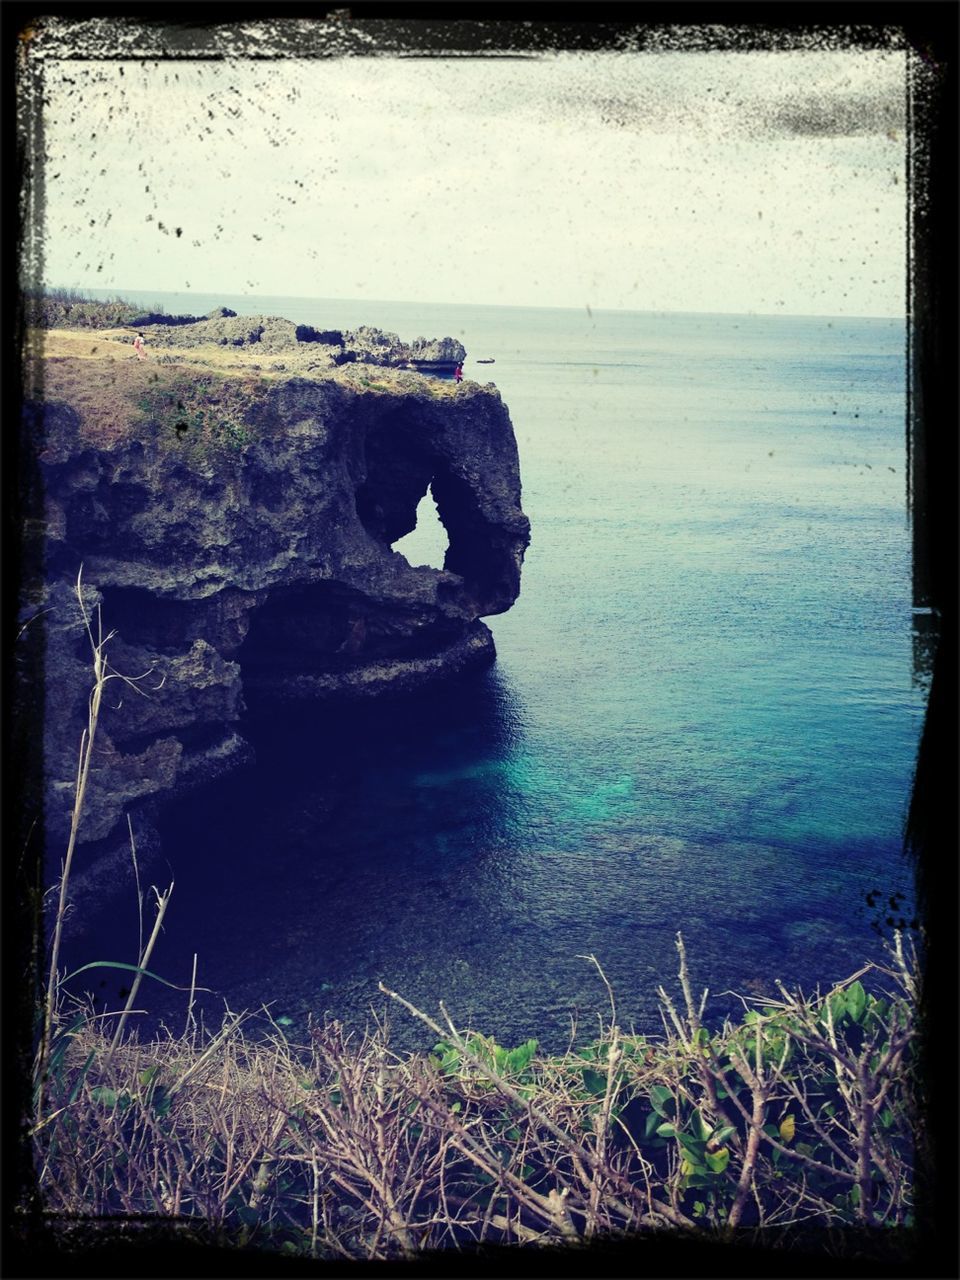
[0,0,960,1276]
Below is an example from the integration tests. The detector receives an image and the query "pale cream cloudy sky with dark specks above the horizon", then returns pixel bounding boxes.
[35,51,906,316]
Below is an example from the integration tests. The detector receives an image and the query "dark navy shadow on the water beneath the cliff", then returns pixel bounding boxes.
[61,668,542,1054]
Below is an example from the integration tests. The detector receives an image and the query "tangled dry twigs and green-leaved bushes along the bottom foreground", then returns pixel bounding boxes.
[31,938,915,1258]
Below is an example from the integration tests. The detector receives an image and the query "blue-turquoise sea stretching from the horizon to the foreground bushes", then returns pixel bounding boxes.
[64,291,928,1051]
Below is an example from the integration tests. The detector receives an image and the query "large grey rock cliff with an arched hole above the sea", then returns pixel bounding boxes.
[24,343,529,880]
